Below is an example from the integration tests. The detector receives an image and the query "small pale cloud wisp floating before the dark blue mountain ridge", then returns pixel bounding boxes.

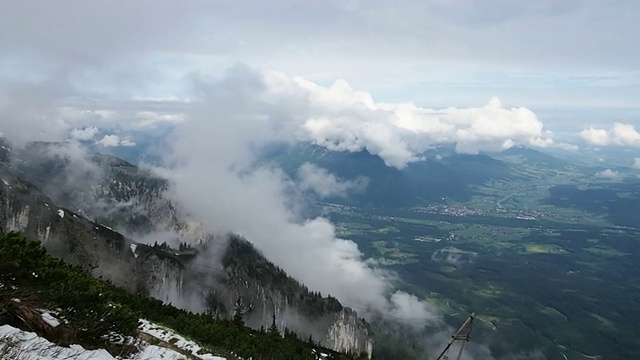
[298,163,368,198]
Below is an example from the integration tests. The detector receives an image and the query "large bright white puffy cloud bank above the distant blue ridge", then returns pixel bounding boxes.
[261,72,554,168]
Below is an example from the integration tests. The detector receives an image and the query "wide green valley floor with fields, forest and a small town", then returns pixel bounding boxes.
[322,201,640,360]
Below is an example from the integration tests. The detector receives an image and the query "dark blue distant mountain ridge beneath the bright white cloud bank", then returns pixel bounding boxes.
[260,144,515,207]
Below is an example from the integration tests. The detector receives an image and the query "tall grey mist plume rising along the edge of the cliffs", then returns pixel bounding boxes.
[165,67,440,324]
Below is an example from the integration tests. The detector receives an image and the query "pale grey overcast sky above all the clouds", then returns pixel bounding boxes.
[0,0,640,109]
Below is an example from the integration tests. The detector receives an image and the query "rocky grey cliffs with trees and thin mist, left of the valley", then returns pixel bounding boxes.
[0,144,373,354]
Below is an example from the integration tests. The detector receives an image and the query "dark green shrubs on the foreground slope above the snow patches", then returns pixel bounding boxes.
[0,233,364,360]
